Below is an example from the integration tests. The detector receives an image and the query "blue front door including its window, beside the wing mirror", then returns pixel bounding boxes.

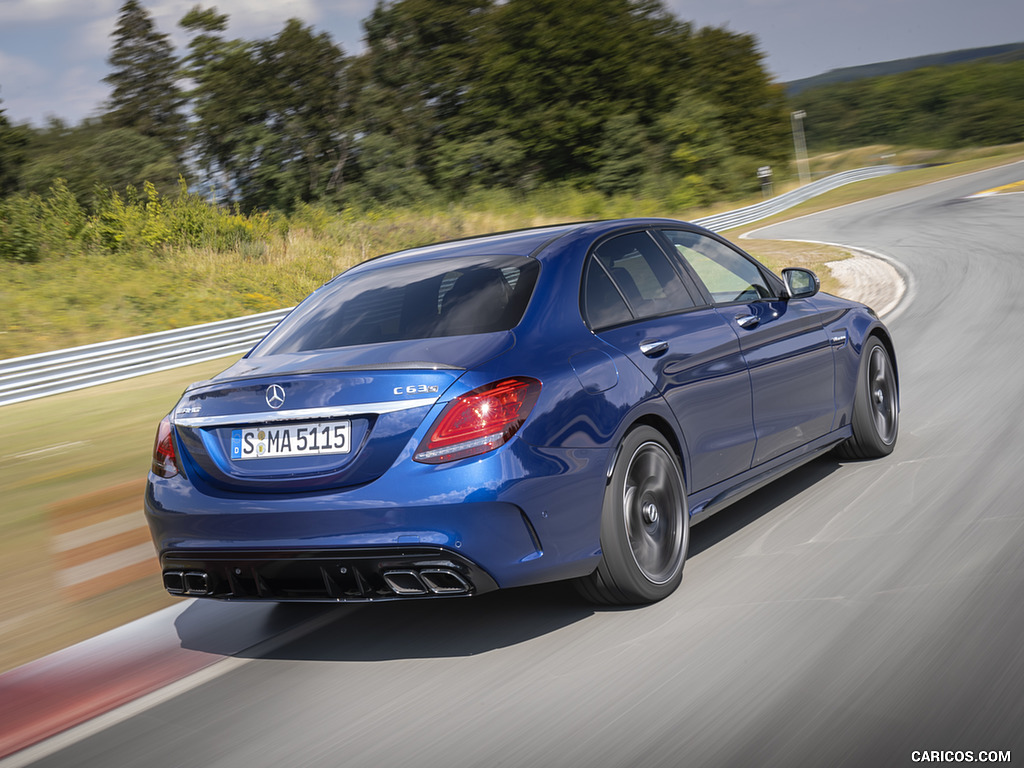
[660,229,836,466]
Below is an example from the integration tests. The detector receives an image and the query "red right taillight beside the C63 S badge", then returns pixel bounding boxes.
[413,377,541,464]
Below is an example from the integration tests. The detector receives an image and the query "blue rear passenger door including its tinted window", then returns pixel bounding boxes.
[583,230,755,493]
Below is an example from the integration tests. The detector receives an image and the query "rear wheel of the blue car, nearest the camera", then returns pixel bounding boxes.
[577,427,690,605]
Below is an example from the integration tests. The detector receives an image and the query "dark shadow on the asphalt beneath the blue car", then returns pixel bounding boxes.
[176,457,841,662]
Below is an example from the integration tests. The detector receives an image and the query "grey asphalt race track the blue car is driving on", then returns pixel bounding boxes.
[18,164,1024,768]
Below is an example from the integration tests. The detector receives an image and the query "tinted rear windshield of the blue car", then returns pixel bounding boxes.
[255,256,540,355]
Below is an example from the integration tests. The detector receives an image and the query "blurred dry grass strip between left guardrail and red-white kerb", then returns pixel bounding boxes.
[0,360,229,671]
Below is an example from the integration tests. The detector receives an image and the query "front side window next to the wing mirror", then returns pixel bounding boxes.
[664,229,775,304]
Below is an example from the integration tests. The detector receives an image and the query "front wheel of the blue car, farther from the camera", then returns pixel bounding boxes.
[836,336,899,459]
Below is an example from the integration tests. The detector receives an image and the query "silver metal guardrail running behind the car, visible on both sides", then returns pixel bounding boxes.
[0,165,906,406]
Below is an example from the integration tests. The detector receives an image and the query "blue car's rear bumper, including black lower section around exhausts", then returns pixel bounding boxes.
[145,443,605,600]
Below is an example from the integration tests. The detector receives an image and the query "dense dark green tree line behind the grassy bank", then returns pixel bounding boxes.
[0,0,788,219]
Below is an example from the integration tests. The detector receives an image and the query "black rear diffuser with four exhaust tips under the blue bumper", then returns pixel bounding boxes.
[160,547,498,602]
